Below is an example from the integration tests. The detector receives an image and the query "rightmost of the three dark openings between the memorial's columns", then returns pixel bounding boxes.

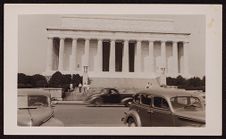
[129,43,135,72]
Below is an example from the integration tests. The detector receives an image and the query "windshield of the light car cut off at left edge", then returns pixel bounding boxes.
[18,95,49,108]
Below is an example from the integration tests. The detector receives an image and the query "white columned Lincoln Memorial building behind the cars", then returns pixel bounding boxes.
[44,16,190,87]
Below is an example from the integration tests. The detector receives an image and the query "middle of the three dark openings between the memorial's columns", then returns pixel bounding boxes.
[115,42,123,71]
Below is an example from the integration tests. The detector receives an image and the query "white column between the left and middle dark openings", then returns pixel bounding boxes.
[109,40,115,72]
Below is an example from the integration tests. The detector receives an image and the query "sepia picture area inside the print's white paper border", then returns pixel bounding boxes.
[17,15,205,127]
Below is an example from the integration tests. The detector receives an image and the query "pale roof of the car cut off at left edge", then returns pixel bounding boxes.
[18,88,51,97]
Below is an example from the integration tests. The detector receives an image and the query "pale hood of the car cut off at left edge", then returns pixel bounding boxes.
[17,107,54,126]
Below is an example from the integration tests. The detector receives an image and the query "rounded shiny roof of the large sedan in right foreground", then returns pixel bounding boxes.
[139,87,198,98]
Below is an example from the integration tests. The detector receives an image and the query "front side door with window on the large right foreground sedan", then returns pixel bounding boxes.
[150,96,174,126]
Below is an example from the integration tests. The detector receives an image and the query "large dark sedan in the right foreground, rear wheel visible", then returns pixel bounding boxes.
[121,88,205,127]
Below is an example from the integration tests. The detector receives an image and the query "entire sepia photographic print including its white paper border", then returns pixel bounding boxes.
[4,5,222,135]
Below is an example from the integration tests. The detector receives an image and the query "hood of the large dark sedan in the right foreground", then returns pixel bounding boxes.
[175,110,205,123]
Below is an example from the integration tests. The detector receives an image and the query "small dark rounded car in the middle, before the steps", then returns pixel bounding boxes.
[85,88,133,106]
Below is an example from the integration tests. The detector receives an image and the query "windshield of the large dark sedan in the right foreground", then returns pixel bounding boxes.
[170,96,202,111]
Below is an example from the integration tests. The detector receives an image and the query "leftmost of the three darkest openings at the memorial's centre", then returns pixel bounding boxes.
[102,42,110,71]
